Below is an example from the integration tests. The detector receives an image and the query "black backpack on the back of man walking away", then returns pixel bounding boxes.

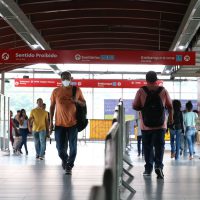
[142,86,165,127]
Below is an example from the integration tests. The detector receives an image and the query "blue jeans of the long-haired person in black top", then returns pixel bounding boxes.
[170,129,182,159]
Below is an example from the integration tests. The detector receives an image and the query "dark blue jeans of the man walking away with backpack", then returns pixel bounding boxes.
[142,129,166,172]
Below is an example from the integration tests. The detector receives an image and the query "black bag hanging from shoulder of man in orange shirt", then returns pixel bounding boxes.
[72,86,88,132]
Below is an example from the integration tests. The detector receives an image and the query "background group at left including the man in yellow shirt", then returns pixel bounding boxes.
[10,101,49,160]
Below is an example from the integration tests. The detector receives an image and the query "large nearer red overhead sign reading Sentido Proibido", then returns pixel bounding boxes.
[0,49,196,65]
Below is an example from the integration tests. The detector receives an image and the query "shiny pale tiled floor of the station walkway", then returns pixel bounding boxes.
[0,142,200,200]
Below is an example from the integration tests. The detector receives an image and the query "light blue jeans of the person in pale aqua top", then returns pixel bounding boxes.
[185,126,196,156]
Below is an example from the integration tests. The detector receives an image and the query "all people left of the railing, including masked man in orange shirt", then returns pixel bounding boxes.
[10,71,86,175]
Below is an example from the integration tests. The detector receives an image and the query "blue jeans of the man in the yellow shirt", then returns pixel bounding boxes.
[33,130,46,157]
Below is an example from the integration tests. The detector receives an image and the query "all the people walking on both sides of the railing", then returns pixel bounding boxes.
[7,71,200,178]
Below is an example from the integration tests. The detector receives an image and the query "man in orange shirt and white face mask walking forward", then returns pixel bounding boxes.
[49,71,85,174]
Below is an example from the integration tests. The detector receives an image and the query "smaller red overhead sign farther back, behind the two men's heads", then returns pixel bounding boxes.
[15,78,163,88]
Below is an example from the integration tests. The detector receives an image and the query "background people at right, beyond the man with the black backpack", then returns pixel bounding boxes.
[134,100,200,160]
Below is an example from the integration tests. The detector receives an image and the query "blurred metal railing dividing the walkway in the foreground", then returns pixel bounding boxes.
[90,100,136,200]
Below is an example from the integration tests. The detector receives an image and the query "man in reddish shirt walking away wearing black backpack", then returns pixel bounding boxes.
[133,71,173,179]
